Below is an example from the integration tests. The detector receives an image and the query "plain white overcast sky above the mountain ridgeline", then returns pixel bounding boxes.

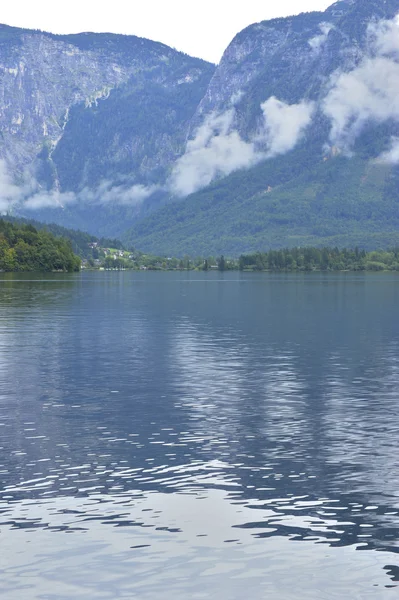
[0,0,334,62]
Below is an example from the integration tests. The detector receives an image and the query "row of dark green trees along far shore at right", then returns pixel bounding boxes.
[238,248,399,271]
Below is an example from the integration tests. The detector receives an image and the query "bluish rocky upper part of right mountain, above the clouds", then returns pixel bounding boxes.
[191,0,399,135]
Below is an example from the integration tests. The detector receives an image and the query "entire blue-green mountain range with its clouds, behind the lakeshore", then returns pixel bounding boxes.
[0,0,399,255]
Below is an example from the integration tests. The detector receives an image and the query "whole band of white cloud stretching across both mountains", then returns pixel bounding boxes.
[0,8,399,212]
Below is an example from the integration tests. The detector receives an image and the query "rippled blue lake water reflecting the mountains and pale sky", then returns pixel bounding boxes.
[0,271,399,600]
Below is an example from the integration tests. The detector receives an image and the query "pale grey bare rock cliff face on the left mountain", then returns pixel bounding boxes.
[0,32,129,170]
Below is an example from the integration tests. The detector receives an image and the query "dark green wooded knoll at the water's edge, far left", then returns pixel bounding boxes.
[0,219,80,272]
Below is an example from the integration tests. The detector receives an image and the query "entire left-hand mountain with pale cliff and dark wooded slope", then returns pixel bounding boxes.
[0,25,214,230]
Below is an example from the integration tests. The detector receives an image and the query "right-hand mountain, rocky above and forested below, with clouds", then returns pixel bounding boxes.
[124,0,399,254]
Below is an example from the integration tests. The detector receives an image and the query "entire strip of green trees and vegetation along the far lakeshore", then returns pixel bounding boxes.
[0,217,399,272]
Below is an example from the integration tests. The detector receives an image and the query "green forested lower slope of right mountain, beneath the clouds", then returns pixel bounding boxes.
[122,148,399,256]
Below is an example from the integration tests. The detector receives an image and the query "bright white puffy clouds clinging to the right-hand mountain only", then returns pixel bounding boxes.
[168,11,399,196]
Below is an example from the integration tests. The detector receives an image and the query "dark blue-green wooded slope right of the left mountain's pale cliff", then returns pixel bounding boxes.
[52,72,208,190]
